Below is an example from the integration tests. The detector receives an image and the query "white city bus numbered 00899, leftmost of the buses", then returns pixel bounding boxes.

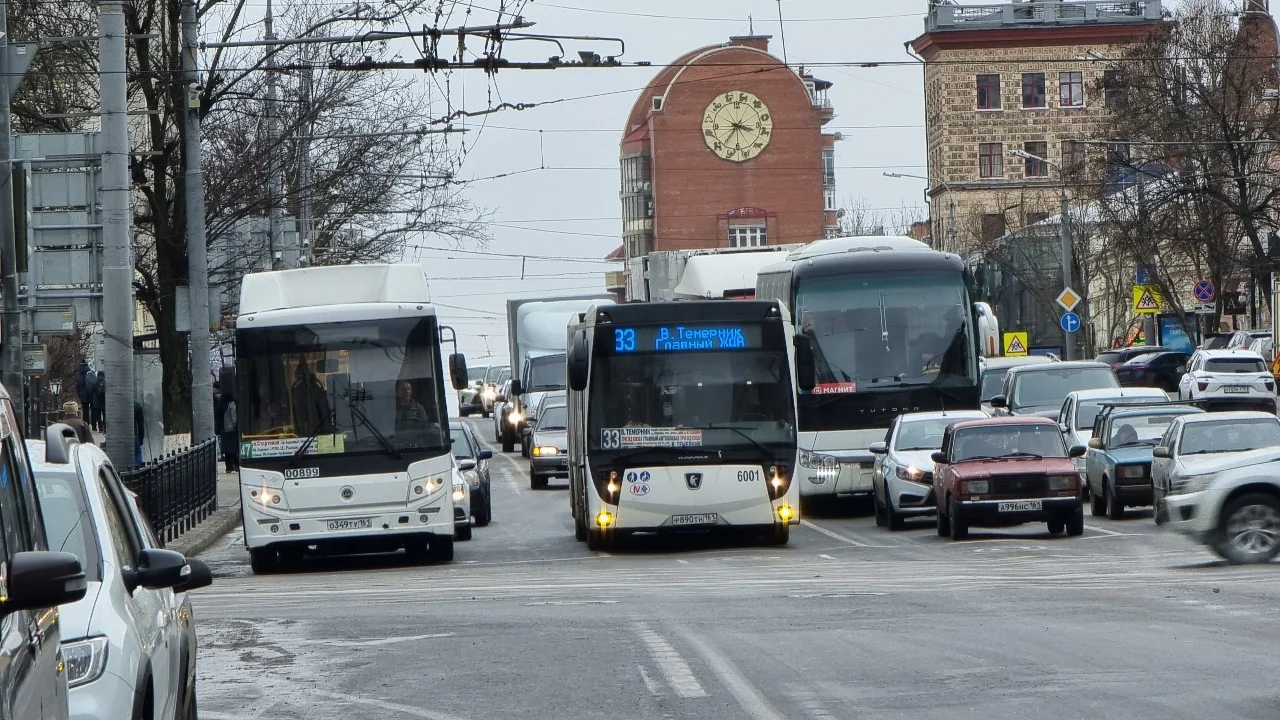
[232,264,467,573]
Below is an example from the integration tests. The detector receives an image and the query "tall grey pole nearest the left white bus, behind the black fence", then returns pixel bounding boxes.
[182,0,214,445]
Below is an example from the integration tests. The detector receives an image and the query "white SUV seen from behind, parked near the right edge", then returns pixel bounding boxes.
[1178,350,1276,413]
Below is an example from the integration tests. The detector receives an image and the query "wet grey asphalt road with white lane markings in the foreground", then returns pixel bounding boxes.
[195,420,1280,720]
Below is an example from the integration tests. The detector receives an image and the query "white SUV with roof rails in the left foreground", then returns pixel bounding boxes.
[27,424,212,720]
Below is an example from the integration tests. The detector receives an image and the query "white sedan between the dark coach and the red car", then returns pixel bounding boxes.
[868,410,987,530]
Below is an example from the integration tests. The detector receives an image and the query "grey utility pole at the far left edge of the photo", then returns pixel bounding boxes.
[0,0,27,429]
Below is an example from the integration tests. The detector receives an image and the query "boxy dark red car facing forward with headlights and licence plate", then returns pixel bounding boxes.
[933,415,1085,539]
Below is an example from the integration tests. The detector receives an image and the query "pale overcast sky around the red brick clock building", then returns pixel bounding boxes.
[407,0,927,365]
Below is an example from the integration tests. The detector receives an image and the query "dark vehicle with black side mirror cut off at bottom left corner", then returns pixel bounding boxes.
[0,379,88,720]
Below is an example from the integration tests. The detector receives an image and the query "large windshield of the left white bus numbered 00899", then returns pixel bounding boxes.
[236,318,449,459]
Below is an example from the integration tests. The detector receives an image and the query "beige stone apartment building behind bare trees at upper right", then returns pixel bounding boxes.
[910,0,1162,252]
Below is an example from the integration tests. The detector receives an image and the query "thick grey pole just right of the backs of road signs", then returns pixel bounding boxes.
[97,0,134,458]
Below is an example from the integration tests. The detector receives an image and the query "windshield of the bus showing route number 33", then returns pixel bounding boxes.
[588,325,795,450]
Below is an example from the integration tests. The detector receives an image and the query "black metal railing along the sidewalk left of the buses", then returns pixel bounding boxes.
[120,439,218,544]
